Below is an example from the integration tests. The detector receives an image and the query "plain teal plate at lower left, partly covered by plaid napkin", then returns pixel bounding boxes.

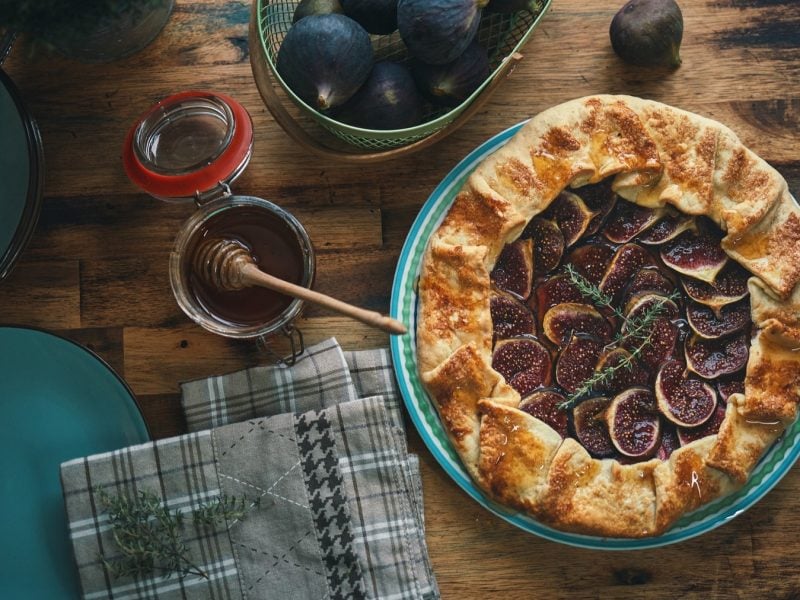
[0,327,150,600]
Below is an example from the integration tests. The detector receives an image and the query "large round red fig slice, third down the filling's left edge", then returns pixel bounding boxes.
[492,337,553,396]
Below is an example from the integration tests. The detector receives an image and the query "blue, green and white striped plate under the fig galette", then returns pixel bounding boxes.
[391,123,800,550]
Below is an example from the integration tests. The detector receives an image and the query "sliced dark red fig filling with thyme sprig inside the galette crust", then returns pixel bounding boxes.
[491,181,752,464]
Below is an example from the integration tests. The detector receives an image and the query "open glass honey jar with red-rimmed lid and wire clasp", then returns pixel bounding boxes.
[123,91,315,362]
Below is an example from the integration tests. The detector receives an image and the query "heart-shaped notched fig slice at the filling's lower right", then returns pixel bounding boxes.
[655,360,717,427]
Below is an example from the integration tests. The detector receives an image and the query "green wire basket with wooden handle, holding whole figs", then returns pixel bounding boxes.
[250,0,552,162]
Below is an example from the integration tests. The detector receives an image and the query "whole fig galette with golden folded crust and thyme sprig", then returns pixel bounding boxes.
[417,96,800,537]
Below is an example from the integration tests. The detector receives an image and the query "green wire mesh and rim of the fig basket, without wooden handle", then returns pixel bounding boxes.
[256,0,551,151]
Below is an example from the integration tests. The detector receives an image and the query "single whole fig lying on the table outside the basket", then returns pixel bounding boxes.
[609,0,683,68]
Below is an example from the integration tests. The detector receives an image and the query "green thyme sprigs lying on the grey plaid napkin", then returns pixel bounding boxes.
[96,489,258,579]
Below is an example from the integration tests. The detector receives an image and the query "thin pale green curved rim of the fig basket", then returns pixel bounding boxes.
[254,0,552,141]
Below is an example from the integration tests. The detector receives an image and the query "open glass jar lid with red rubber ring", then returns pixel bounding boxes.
[122,91,253,200]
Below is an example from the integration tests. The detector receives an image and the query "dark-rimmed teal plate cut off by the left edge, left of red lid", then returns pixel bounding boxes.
[0,69,44,279]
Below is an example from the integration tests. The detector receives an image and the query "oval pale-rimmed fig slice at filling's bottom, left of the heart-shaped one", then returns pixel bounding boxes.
[606,387,661,458]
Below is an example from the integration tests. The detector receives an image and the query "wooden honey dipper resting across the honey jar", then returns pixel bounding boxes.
[192,238,408,334]
